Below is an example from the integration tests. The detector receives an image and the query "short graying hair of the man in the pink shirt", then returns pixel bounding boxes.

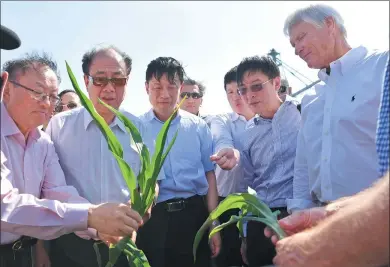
[3,51,61,83]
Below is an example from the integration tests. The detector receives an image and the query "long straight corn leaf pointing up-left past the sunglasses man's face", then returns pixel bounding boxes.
[65,61,123,157]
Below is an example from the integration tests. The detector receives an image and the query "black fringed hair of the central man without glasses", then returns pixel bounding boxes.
[146,57,187,83]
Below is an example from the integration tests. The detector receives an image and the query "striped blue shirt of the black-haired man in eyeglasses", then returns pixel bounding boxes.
[239,100,301,208]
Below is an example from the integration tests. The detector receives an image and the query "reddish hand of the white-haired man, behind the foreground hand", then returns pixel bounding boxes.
[264,207,329,244]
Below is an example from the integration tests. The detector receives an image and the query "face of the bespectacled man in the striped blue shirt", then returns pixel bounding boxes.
[239,71,280,114]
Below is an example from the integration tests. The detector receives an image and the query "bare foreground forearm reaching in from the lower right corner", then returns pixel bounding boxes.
[309,174,389,267]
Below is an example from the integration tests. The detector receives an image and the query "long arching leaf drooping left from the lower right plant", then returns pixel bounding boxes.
[193,193,283,261]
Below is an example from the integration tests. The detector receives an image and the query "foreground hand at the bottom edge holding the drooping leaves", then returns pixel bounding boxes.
[273,230,324,267]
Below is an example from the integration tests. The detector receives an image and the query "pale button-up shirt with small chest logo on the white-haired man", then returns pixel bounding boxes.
[288,46,389,212]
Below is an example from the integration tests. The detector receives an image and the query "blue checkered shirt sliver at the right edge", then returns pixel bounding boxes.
[376,61,390,176]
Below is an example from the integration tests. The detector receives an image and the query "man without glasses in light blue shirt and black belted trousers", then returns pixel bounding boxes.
[137,57,220,267]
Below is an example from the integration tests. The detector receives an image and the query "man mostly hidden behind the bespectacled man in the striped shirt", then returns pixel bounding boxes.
[210,67,255,267]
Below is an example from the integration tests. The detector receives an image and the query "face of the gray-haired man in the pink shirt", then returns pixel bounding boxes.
[4,65,58,131]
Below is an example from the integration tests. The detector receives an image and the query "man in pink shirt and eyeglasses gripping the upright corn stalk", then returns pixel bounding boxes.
[0,48,141,267]
